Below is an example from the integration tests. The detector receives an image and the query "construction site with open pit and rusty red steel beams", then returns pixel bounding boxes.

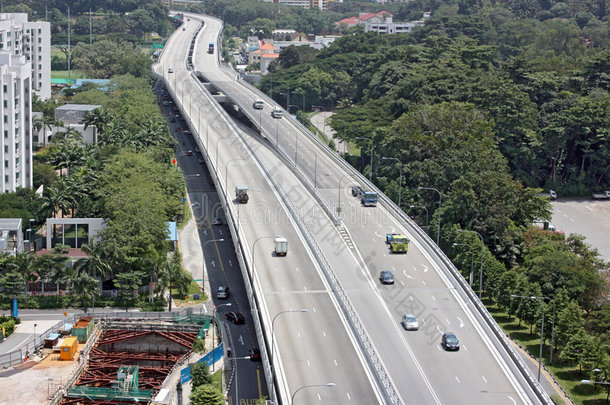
[0,313,214,405]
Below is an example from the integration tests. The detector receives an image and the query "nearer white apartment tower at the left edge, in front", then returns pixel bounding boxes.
[0,52,32,193]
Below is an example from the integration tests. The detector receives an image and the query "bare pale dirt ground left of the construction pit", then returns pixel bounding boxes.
[0,344,84,405]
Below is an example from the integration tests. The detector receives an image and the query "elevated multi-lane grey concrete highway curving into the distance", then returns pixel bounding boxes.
[156,15,541,404]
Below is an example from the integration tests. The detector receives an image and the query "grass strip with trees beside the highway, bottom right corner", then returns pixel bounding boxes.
[487,305,606,405]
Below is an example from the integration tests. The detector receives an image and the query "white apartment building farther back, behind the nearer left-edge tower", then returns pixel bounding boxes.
[0,13,51,100]
